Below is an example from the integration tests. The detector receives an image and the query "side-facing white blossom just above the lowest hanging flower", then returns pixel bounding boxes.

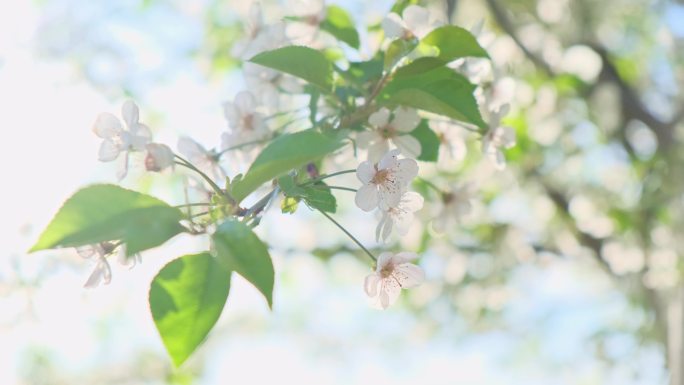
[375,191,424,241]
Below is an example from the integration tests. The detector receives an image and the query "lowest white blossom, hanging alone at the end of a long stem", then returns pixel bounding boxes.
[364,252,425,309]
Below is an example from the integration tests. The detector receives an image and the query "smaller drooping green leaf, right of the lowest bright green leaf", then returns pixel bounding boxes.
[211,219,275,307]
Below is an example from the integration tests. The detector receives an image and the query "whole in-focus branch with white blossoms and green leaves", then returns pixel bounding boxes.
[31,1,515,365]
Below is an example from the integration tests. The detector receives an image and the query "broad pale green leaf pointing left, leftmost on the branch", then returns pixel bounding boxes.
[30,184,185,255]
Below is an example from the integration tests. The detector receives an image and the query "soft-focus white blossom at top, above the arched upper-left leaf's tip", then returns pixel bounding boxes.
[230,2,286,60]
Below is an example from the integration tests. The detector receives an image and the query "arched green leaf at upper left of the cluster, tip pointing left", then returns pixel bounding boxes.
[249,45,332,92]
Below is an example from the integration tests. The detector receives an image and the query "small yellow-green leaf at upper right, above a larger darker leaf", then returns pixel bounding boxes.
[421,25,489,62]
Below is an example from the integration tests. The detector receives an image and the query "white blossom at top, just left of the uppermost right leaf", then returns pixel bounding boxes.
[382,5,439,39]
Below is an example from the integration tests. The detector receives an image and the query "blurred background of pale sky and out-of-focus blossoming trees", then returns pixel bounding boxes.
[0,0,684,385]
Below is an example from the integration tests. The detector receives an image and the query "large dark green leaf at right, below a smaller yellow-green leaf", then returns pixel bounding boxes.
[378,67,487,128]
